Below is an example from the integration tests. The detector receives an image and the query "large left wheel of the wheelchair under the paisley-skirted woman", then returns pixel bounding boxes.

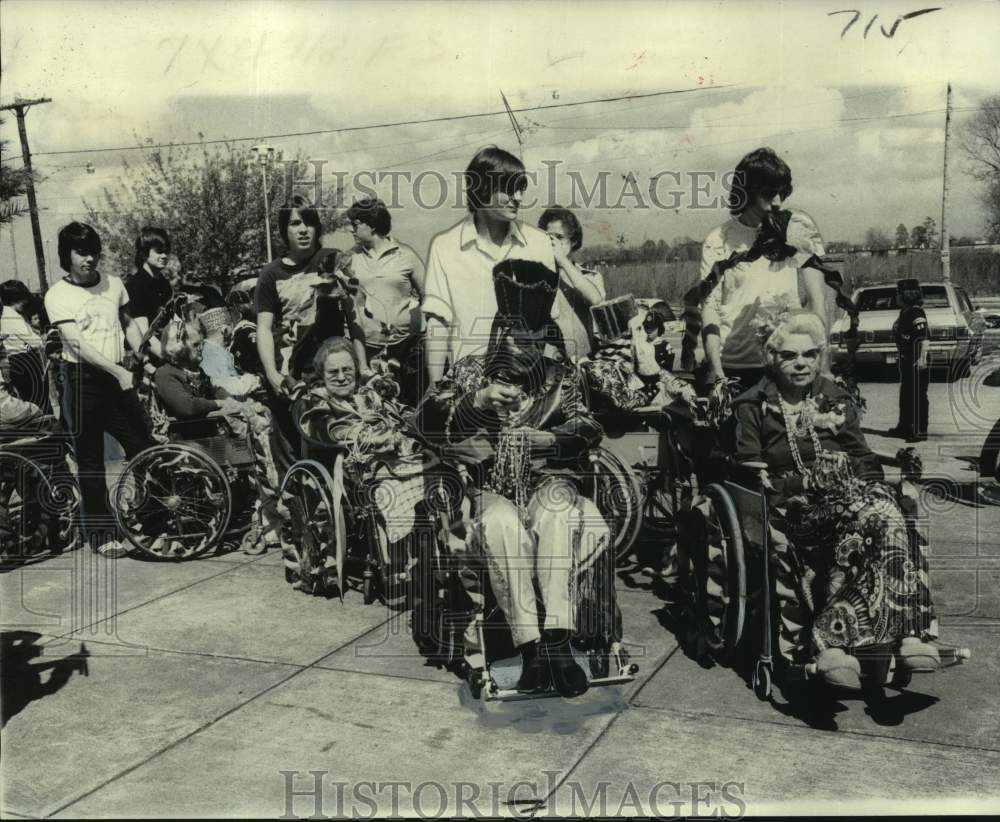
[695,483,747,658]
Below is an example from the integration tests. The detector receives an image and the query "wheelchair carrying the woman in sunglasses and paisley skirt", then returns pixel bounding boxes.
[678,449,971,700]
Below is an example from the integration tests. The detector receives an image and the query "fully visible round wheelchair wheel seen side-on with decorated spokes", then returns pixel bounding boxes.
[112,443,233,559]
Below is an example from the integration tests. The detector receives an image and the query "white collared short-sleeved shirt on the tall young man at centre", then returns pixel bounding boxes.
[421,214,556,363]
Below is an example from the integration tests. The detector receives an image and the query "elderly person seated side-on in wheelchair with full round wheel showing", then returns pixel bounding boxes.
[115,318,281,559]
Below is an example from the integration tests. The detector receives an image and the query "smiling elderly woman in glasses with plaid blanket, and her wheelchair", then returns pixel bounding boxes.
[282,337,446,602]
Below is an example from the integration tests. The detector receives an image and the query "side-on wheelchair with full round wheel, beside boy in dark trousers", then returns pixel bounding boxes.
[111,412,266,560]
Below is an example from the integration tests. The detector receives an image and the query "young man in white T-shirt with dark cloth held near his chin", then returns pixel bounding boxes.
[701,148,826,390]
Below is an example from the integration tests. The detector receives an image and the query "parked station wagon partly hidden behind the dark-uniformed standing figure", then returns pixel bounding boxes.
[830,283,986,373]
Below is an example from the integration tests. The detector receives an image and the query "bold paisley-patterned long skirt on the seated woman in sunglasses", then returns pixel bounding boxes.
[788,480,934,651]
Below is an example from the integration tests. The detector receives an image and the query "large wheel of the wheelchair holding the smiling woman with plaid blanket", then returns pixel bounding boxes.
[281,460,344,596]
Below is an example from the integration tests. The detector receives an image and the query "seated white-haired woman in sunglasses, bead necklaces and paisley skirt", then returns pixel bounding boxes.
[708,311,961,691]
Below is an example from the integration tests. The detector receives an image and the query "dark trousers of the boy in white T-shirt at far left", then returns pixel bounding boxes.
[62,363,155,547]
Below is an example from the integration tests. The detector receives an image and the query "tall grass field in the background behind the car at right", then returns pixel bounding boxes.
[603,248,1000,305]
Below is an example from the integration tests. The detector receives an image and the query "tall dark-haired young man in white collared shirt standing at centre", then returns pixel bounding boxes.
[421,146,556,385]
